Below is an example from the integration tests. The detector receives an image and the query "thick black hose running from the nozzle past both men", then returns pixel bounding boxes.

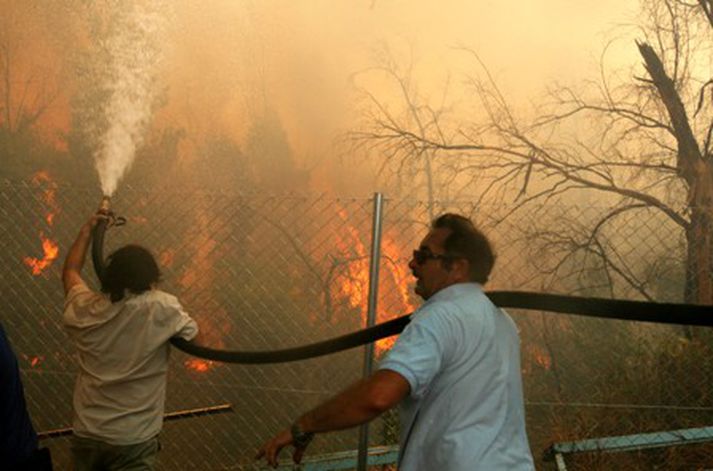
[92,214,713,364]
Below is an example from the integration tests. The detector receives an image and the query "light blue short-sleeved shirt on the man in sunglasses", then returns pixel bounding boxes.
[380,283,534,471]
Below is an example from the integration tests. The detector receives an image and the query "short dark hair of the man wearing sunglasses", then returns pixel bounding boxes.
[431,213,495,284]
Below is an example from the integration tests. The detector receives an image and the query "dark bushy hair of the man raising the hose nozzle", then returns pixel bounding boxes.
[101,244,161,303]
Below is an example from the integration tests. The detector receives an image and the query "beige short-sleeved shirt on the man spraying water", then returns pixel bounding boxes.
[63,284,198,445]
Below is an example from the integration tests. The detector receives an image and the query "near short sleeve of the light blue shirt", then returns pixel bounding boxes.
[379,304,446,399]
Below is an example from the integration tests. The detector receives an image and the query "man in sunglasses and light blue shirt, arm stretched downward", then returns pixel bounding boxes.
[257,214,535,471]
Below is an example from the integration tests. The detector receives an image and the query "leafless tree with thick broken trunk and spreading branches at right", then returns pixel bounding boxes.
[351,0,713,304]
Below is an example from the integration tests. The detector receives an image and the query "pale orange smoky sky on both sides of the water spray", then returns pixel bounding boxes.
[2,0,637,192]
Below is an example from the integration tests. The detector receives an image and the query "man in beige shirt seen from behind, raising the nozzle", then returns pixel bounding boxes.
[62,213,198,471]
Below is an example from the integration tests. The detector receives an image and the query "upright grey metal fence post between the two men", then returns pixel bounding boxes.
[357,193,384,471]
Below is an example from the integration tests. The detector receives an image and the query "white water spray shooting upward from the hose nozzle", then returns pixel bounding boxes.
[74,0,170,196]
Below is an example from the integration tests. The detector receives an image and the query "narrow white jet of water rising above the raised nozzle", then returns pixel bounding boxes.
[89,0,165,196]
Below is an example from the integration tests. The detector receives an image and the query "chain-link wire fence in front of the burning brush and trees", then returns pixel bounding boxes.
[0,177,713,469]
